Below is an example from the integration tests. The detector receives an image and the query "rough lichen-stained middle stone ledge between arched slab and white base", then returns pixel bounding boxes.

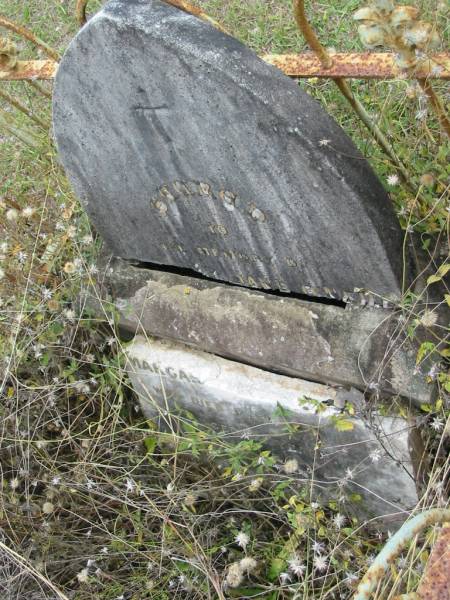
[83,252,435,406]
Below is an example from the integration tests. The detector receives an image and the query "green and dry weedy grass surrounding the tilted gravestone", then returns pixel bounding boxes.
[0,0,450,600]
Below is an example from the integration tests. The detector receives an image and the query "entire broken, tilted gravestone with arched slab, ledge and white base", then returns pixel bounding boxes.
[54,0,431,518]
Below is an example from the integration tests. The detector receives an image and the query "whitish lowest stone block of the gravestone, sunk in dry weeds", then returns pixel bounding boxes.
[127,337,418,525]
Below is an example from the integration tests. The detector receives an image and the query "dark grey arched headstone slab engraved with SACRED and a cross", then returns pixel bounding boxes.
[54,0,402,298]
